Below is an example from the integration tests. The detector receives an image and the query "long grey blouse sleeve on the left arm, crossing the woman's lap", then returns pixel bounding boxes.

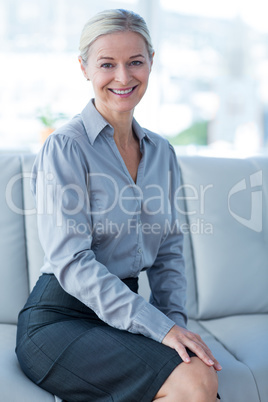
[32,134,175,342]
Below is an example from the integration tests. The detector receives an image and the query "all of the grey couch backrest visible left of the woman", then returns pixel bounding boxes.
[0,154,43,324]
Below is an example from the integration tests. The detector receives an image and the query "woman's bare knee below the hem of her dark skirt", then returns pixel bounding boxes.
[154,357,218,402]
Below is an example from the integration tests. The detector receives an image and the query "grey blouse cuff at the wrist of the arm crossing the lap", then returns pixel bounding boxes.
[129,303,175,343]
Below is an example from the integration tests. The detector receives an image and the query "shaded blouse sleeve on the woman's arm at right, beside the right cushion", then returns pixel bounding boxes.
[147,146,187,328]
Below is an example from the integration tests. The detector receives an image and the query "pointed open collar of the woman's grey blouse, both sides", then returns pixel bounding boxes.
[81,99,155,145]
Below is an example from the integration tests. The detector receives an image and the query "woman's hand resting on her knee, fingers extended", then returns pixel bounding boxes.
[162,325,222,371]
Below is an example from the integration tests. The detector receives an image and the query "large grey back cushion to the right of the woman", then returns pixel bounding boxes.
[179,157,268,319]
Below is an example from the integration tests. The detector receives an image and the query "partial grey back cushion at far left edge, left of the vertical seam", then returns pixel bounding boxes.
[0,155,29,323]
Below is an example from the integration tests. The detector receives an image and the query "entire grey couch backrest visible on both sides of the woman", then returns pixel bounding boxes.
[0,155,268,323]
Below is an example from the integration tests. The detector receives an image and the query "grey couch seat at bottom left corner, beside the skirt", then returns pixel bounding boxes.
[0,324,55,402]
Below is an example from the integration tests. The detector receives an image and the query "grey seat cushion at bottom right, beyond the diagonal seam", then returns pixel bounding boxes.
[201,314,268,401]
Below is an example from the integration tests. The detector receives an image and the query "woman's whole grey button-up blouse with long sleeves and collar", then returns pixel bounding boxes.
[31,100,186,342]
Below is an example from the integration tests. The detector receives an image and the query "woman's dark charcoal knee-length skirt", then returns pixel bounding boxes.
[16,274,195,402]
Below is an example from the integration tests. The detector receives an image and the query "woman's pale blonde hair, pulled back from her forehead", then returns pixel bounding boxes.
[79,9,154,64]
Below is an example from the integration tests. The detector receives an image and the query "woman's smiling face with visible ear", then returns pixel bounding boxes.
[79,31,152,121]
